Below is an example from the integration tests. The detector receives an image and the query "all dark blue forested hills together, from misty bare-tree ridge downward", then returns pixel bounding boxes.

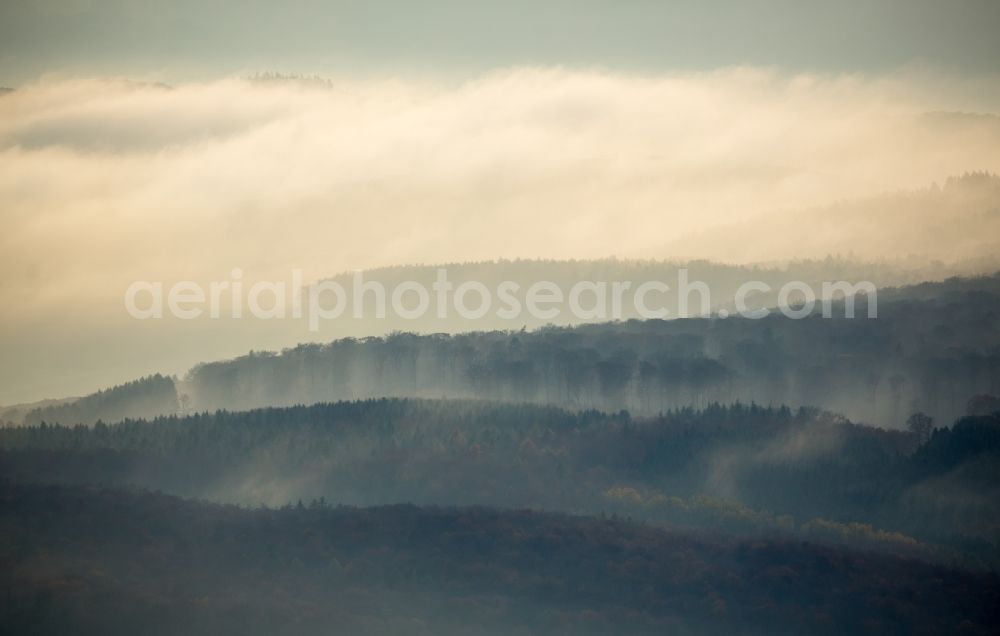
[7,275,1000,635]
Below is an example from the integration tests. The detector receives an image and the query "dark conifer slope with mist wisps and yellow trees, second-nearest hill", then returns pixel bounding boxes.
[7,399,1000,567]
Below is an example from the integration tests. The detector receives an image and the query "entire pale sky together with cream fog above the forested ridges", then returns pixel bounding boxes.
[0,0,1000,403]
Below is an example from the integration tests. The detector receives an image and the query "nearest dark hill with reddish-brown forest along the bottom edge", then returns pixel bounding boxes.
[0,484,1000,636]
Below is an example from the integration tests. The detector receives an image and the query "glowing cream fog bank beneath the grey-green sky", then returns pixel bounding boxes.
[0,68,1000,402]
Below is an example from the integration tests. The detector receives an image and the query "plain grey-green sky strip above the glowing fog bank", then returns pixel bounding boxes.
[0,0,1000,85]
